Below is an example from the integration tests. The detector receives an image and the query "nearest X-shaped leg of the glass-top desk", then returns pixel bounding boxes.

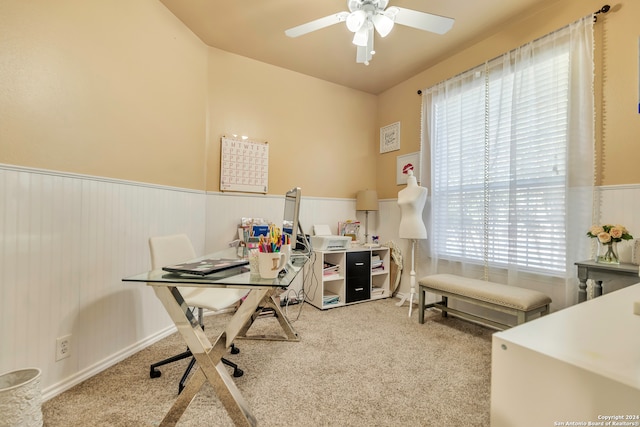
[154,286,257,426]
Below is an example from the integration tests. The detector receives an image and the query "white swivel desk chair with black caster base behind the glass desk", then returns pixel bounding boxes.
[149,234,248,394]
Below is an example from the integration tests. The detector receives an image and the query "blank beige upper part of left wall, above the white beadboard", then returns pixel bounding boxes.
[0,0,207,189]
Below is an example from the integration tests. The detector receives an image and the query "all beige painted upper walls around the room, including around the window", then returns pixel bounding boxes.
[0,0,640,198]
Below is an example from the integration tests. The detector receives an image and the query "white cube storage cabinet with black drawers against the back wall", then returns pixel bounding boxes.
[305,247,391,310]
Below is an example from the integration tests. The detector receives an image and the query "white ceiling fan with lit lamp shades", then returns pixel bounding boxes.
[284,0,454,65]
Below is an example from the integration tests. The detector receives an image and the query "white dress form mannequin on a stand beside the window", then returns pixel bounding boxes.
[397,170,428,317]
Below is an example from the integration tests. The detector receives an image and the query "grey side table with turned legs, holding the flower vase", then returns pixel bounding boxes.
[576,261,640,303]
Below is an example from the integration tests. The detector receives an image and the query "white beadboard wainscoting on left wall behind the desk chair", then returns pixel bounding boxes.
[0,166,205,399]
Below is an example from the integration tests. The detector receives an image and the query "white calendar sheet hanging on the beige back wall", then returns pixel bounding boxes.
[220,137,269,194]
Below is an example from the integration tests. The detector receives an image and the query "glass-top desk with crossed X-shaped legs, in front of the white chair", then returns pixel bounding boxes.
[122,250,306,426]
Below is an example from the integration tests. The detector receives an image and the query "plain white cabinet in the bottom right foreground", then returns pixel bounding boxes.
[491,284,640,427]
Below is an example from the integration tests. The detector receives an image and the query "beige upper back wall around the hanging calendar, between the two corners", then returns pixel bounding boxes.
[207,48,378,197]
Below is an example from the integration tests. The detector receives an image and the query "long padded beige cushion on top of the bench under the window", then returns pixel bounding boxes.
[418,274,551,311]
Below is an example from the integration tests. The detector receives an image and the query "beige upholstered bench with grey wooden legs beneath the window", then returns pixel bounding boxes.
[418,274,551,329]
